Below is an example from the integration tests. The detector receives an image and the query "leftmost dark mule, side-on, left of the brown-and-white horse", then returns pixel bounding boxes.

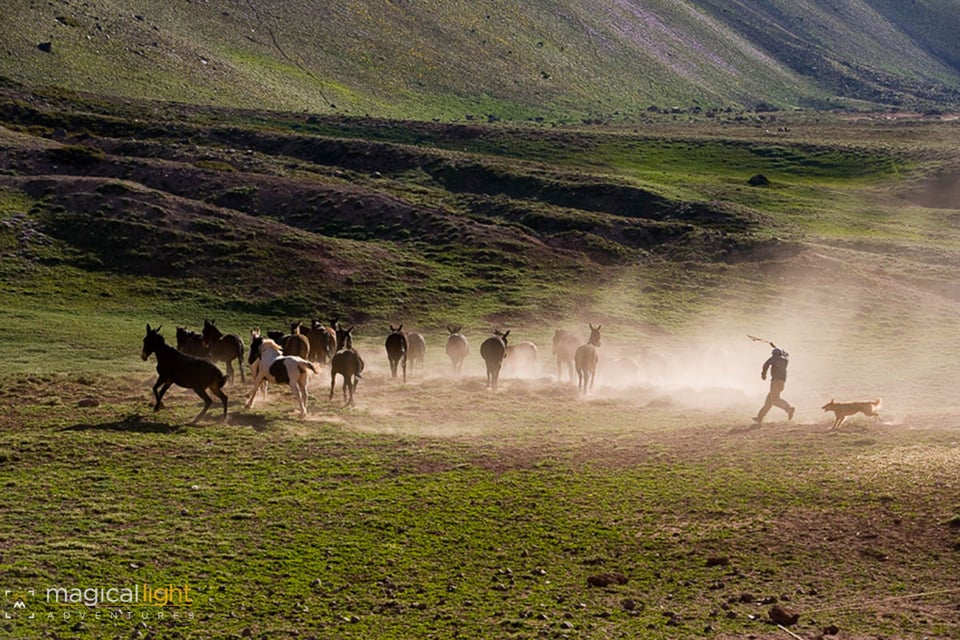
[140,324,227,424]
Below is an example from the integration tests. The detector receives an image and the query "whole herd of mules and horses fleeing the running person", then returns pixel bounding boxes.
[140,319,600,423]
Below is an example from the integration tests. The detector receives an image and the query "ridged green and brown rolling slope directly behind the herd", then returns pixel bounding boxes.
[0,86,960,412]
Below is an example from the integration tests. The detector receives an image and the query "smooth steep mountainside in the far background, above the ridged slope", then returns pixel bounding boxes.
[0,0,960,122]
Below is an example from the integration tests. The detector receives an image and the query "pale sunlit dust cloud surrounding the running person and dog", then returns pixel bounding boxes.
[294,246,960,427]
